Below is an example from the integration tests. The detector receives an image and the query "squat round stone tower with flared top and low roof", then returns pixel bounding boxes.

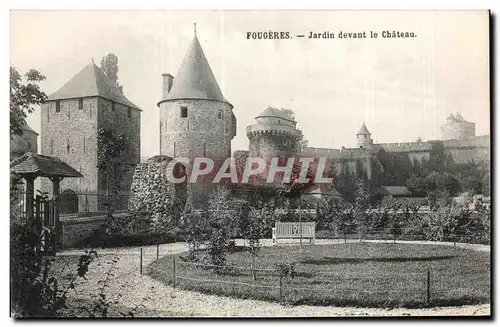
[247,107,302,158]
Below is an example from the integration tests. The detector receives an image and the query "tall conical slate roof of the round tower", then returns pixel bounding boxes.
[163,35,229,103]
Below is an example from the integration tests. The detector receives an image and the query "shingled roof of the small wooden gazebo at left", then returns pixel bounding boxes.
[10,152,83,177]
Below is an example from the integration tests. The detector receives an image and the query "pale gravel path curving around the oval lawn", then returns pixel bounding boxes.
[58,240,490,317]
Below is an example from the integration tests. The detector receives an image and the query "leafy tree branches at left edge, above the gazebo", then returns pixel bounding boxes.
[10,66,47,137]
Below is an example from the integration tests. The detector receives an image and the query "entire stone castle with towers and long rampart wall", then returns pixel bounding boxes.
[37,32,490,199]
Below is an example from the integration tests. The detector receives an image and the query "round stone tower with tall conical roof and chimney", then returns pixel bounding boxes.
[158,34,236,162]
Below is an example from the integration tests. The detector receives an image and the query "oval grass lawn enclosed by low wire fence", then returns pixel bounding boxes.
[147,243,490,308]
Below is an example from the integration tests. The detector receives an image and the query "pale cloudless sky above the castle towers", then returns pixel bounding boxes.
[10,10,490,157]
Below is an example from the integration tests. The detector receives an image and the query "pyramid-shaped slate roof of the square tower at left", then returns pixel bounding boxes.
[48,61,141,110]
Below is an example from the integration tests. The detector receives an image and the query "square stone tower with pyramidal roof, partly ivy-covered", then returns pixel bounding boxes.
[40,61,141,197]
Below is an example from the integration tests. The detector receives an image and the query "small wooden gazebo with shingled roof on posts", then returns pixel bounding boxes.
[10,152,83,254]
